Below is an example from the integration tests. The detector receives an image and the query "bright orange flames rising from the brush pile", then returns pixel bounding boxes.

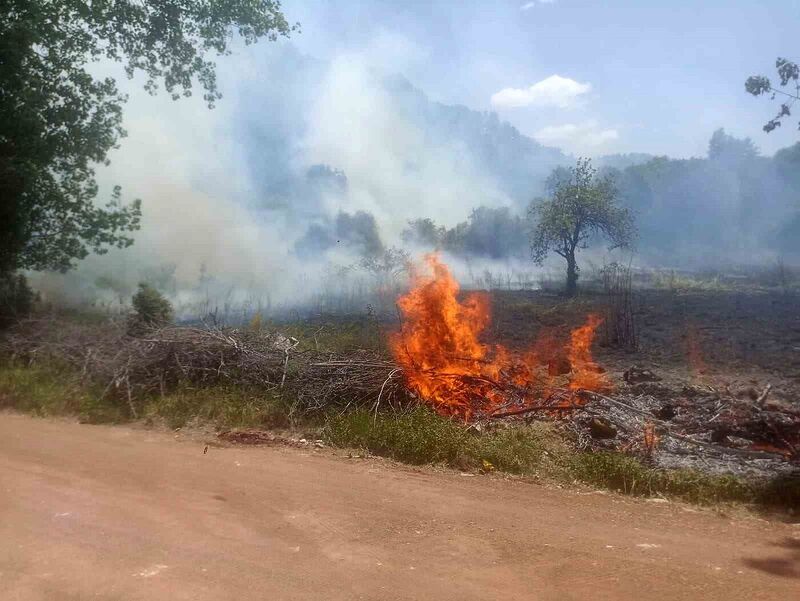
[389,253,608,417]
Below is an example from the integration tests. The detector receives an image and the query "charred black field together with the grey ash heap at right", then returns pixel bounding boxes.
[487,290,800,476]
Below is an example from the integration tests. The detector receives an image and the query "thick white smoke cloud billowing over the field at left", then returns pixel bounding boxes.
[35,36,524,314]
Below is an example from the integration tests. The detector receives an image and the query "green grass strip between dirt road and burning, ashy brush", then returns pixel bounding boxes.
[324,407,800,507]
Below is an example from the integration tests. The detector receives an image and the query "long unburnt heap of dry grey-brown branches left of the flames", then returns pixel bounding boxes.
[0,318,418,417]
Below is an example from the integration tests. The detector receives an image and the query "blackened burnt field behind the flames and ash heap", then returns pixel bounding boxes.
[490,290,800,405]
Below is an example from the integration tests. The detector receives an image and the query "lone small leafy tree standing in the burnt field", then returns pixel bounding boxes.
[530,159,636,296]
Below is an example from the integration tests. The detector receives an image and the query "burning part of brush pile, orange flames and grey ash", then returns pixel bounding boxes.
[390,255,800,474]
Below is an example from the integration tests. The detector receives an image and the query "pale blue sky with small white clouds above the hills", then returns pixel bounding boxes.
[283,0,800,157]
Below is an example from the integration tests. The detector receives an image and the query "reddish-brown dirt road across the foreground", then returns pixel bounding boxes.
[0,414,800,601]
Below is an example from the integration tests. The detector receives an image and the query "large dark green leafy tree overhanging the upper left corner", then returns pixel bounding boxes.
[0,0,296,273]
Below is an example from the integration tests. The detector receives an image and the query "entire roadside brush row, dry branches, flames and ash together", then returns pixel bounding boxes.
[0,255,800,474]
